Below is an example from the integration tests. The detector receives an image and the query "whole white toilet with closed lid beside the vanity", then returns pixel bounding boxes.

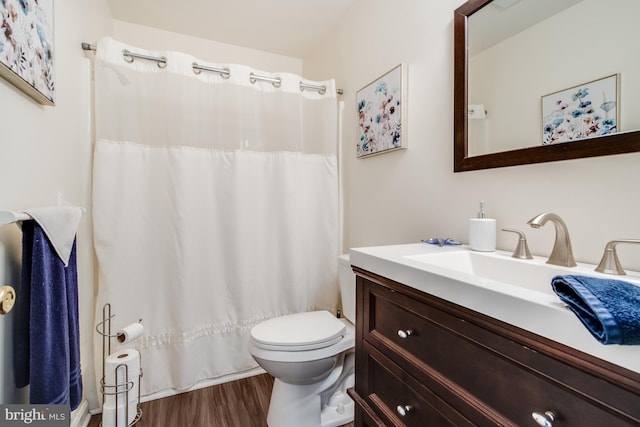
[249,255,356,427]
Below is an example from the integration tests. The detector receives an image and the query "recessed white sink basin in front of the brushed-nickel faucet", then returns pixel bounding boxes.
[406,251,636,295]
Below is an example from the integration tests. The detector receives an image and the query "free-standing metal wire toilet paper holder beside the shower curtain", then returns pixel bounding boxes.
[96,303,142,427]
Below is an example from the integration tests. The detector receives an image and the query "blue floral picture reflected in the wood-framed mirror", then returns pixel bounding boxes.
[542,74,618,145]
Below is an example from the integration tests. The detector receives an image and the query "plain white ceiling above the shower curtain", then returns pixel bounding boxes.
[108,0,358,58]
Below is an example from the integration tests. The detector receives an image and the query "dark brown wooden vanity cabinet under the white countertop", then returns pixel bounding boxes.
[350,267,640,427]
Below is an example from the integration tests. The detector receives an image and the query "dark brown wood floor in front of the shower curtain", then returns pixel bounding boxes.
[88,374,353,427]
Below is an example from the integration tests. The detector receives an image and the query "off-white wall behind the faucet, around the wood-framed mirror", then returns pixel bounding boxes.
[304,0,640,270]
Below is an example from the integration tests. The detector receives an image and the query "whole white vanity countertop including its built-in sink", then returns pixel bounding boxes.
[350,243,640,373]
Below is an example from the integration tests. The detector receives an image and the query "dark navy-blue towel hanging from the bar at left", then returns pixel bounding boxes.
[14,221,82,410]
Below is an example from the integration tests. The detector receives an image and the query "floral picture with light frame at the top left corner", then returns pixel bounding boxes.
[0,0,55,105]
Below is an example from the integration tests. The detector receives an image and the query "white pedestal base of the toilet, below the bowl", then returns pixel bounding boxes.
[267,355,354,427]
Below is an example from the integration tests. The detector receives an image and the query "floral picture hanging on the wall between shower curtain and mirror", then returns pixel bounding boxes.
[356,64,407,158]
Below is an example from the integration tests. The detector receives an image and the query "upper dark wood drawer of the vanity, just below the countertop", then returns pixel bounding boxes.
[363,276,640,426]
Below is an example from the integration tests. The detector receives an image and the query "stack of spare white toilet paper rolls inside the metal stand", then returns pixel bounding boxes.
[102,349,140,427]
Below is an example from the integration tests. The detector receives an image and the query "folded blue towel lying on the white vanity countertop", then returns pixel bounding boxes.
[551,275,640,345]
